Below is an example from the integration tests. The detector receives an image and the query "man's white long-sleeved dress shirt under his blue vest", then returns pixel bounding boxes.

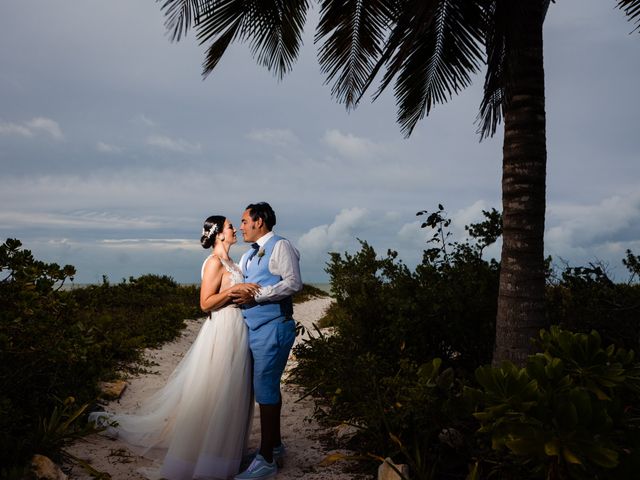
[240,232,302,303]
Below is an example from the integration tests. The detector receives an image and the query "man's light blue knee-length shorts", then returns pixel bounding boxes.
[249,317,296,405]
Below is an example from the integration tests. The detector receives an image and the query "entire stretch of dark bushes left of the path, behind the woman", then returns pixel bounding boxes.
[0,239,200,475]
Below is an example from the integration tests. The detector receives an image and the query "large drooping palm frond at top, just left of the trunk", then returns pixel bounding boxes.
[374,0,485,137]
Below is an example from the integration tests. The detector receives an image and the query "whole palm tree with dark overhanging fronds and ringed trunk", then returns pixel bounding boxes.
[159,0,640,364]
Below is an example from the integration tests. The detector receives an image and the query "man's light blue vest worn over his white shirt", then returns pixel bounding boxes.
[242,235,293,330]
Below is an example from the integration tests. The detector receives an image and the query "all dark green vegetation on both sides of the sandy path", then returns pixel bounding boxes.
[0,212,640,480]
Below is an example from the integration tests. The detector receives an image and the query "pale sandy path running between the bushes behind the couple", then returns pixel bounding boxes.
[69,298,356,480]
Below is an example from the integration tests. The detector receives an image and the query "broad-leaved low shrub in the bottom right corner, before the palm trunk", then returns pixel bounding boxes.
[466,327,640,480]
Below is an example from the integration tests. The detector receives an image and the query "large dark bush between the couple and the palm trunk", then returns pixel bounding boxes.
[294,207,500,478]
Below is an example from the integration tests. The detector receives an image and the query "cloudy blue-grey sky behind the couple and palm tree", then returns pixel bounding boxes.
[0,0,640,283]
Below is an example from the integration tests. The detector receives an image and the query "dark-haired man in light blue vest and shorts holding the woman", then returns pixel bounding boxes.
[233,202,302,480]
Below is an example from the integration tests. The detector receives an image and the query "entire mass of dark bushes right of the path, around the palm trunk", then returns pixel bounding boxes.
[294,206,640,480]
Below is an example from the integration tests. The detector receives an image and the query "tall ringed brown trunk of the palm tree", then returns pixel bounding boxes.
[493,0,547,365]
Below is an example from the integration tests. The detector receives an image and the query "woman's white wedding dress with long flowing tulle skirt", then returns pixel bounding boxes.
[90,256,253,480]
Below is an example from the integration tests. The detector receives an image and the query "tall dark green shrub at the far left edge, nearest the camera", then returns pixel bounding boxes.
[0,239,92,466]
